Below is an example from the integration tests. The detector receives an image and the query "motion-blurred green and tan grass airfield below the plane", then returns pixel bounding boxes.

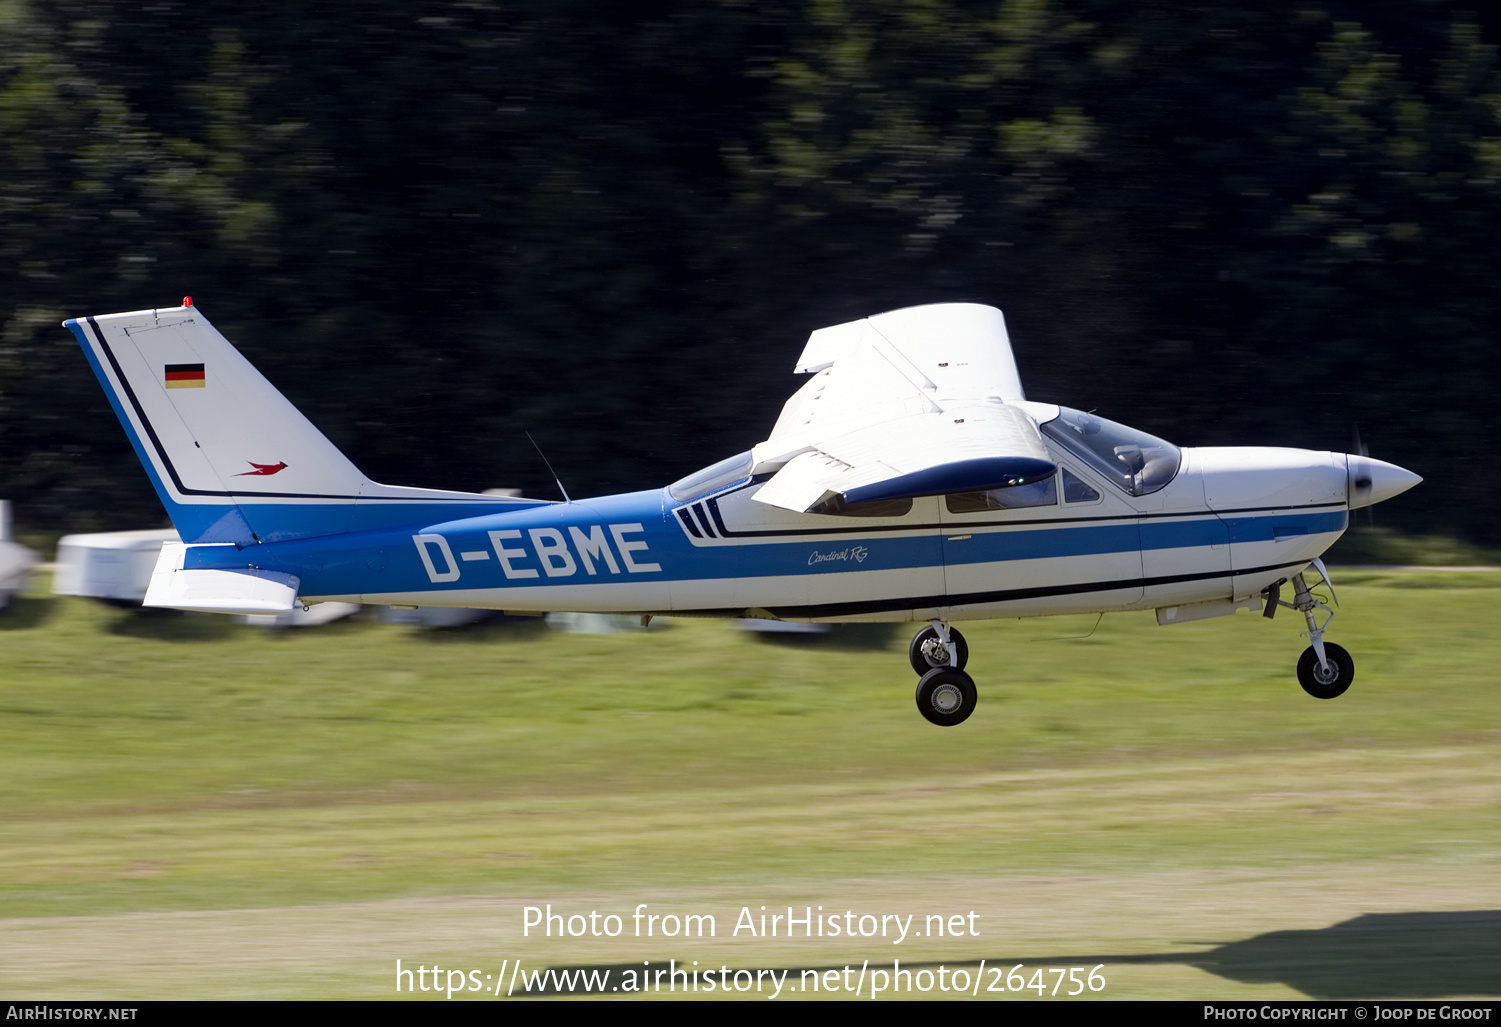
[0,568,1501,1000]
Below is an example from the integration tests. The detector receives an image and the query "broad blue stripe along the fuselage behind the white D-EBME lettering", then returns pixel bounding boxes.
[188,491,1346,596]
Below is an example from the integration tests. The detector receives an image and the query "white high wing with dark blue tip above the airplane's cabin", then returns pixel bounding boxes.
[752,303,1057,512]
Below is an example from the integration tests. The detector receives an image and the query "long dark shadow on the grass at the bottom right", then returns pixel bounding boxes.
[515,910,1501,1000]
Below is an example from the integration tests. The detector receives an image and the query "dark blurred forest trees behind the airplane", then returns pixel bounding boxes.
[0,0,1501,545]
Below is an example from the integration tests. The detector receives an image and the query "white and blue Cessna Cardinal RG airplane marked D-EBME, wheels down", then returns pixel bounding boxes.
[65,299,1421,725]
